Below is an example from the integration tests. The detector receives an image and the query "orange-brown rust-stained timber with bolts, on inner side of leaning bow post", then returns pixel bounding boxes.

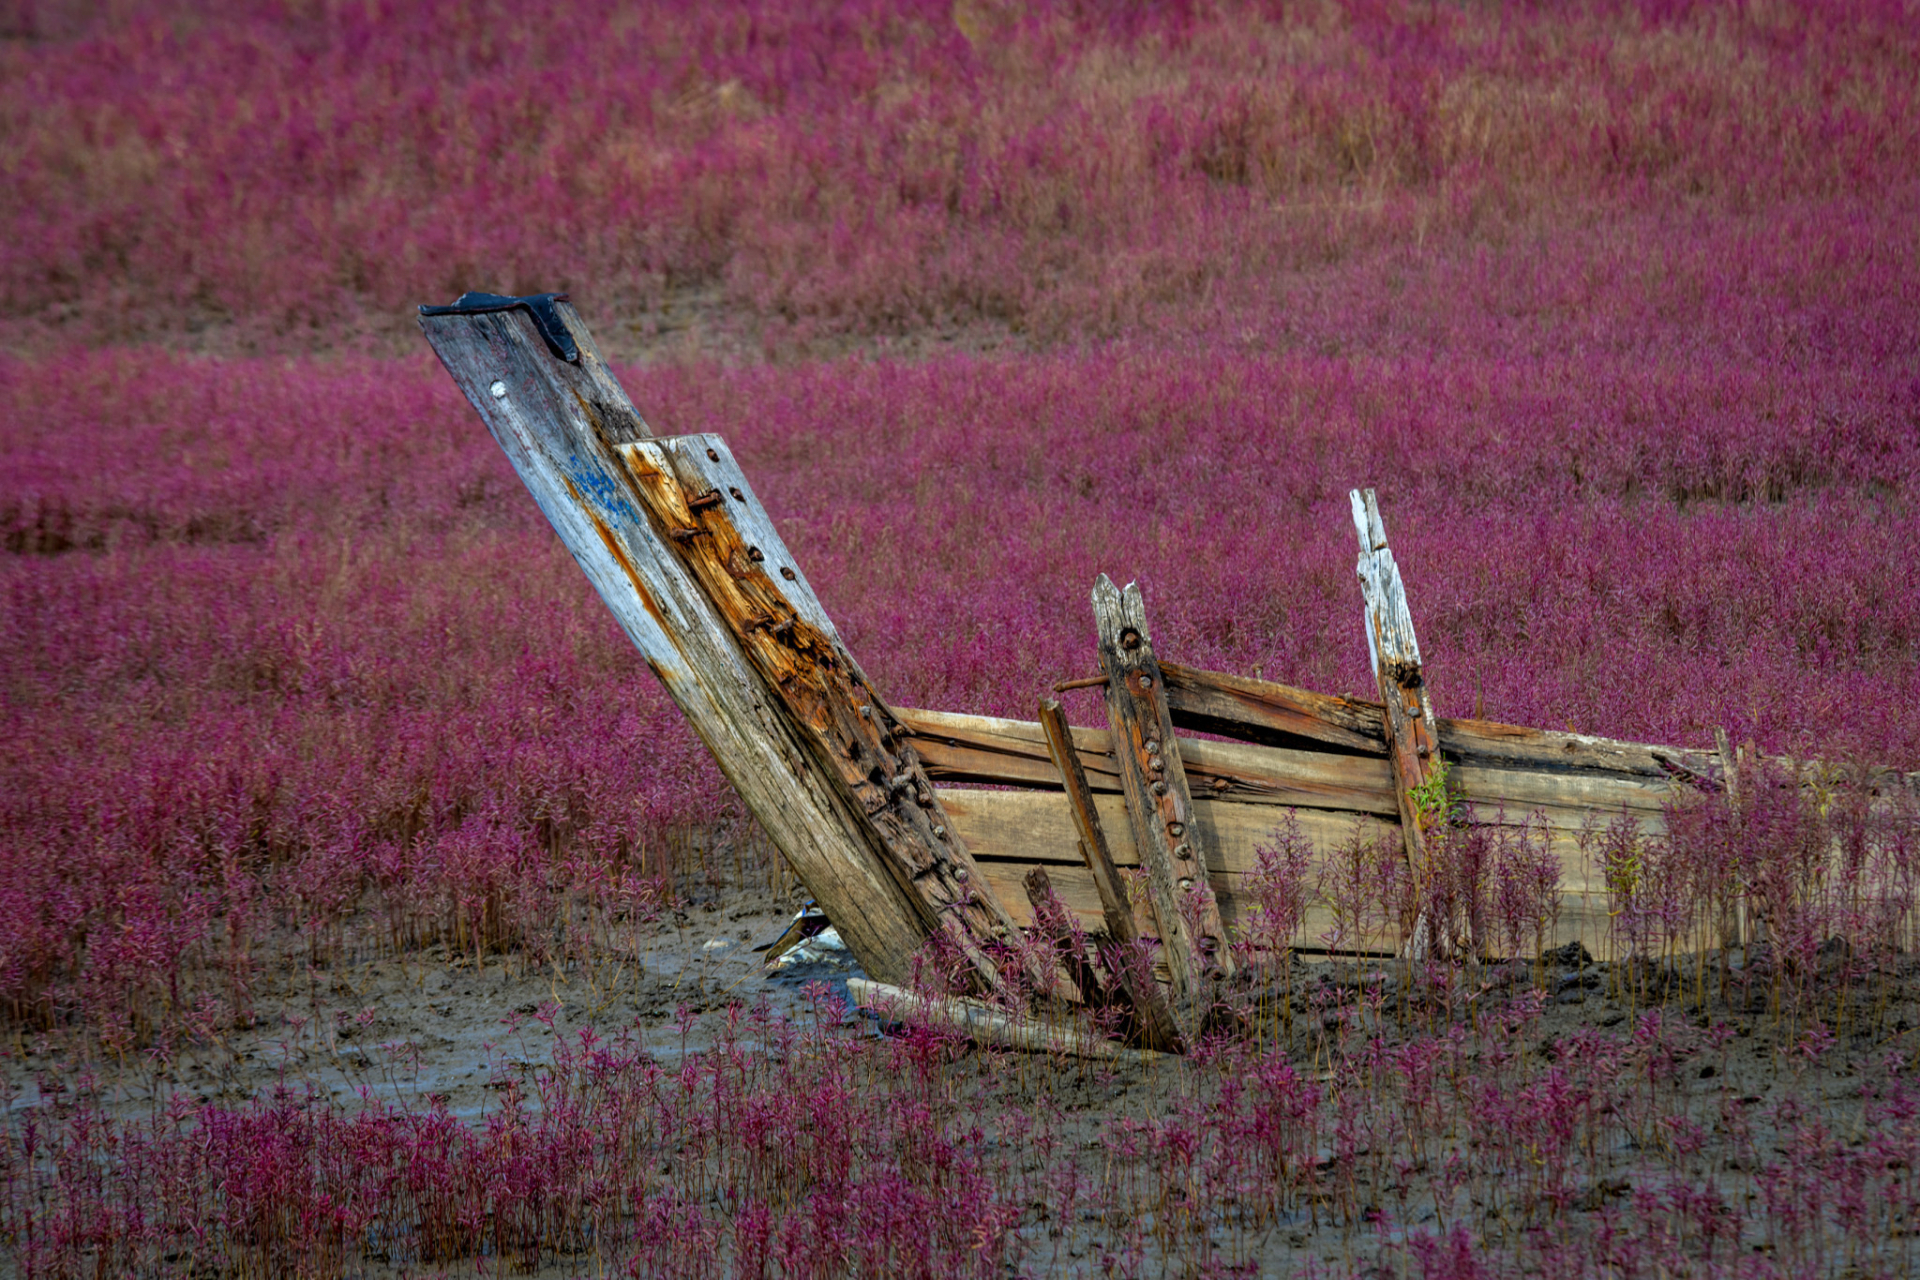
[614,436,1014,986]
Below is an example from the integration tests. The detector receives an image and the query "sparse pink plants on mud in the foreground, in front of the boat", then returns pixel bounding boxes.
[11,971,1920,1276]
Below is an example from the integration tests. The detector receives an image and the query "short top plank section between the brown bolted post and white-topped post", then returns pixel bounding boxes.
[1160,662,1386,756]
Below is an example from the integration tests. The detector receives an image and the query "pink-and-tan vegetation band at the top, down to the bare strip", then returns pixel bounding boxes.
[0,0,1920,349]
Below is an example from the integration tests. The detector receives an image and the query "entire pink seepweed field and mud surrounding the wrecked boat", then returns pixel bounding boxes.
[0,0,1920,1280]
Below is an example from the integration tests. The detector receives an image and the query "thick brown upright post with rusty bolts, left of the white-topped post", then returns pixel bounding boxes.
[1092,574,1233,1044]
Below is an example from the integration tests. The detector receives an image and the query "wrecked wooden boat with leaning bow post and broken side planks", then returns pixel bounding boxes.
[420,294,1758,1048]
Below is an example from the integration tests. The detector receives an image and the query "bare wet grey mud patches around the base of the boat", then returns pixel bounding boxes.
[0,859,1920,1278]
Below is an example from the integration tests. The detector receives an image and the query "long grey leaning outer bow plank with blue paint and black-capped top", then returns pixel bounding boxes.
[420,303,925,981]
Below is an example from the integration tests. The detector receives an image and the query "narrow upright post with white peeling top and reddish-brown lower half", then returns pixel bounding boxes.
[1348,489,1440,958]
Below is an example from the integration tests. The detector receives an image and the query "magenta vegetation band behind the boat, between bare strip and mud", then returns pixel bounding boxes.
[11,337,1920,1038]
